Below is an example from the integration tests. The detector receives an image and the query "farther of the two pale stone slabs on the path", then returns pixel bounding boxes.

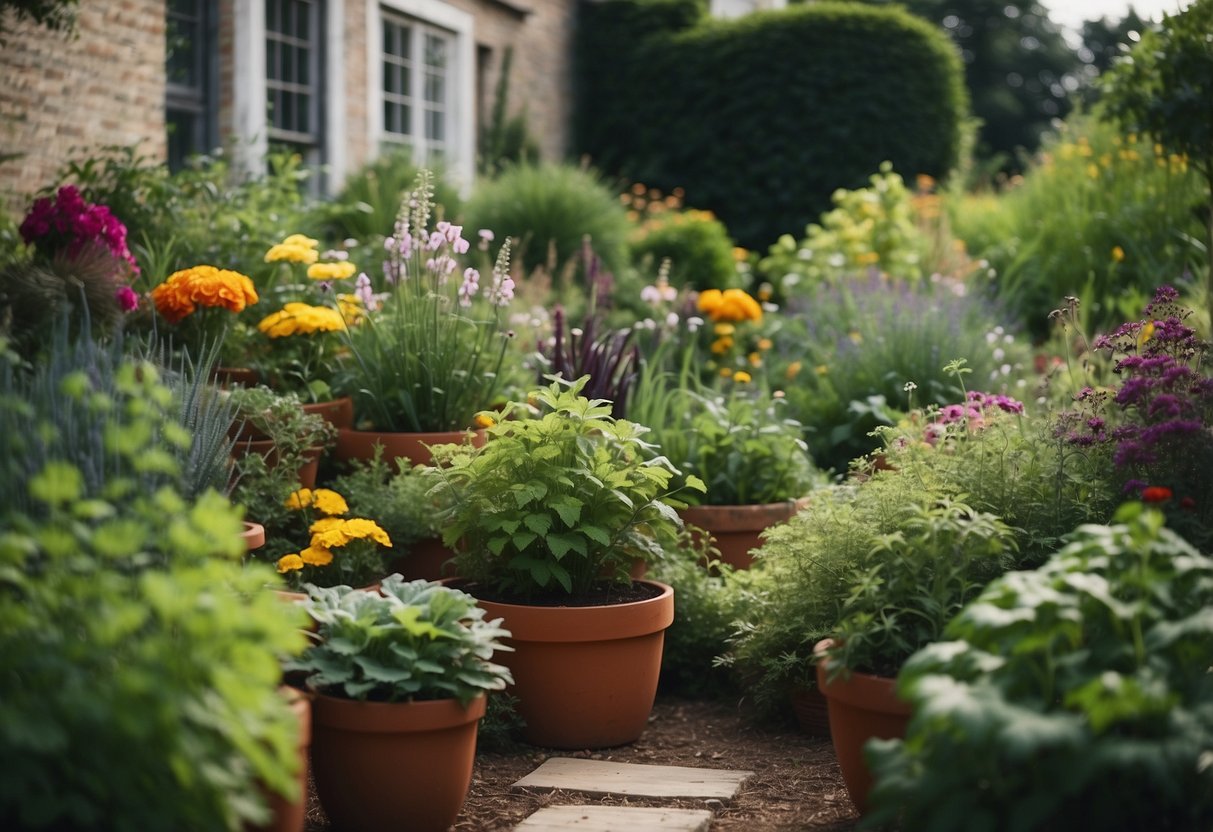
[513,757,753,800]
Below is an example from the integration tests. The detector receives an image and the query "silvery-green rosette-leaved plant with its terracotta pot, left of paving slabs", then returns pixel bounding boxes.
[286,575,511,832]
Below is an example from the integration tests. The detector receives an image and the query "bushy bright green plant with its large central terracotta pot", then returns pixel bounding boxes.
[427,377,702,748]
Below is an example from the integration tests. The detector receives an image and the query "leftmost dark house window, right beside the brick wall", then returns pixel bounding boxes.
[165,0,216,170]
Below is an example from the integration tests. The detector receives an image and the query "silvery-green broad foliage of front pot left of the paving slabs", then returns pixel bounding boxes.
[285,575,513,706]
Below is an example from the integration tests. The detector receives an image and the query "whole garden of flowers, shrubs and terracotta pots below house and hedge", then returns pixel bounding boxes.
[0,0,1213,832]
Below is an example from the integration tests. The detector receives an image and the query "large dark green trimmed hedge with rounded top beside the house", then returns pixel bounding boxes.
[576,0,968,249]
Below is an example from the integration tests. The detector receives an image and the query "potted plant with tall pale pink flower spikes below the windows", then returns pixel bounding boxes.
[337,170,514,463]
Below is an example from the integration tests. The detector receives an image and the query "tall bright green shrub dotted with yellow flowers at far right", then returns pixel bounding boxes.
[952,118,1205,337]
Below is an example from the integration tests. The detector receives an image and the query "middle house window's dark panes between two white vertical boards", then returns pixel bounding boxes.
[266,0,323,155]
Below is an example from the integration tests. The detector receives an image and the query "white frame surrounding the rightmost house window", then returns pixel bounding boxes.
[366,0,475,189]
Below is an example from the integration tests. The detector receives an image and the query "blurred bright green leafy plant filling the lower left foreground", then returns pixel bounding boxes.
[0,327,303,832]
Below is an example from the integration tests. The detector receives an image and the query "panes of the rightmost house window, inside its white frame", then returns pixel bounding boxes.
[383,13,454,163]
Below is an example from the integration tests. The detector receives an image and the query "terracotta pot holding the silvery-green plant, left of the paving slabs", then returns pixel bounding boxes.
[312,695,485,832]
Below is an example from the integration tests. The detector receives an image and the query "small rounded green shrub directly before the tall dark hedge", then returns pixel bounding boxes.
[631,211,741,290]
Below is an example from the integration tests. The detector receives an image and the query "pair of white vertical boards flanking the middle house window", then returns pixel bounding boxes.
[232,0,347,186]
